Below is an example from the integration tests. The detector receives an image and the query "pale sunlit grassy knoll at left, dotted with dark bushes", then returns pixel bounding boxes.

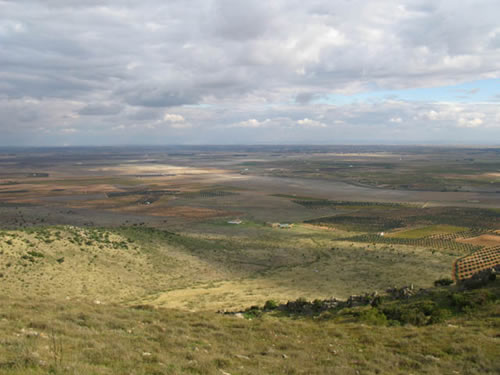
[0,227,229,302]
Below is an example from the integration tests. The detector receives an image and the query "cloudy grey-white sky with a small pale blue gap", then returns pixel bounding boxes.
[0,0,500,146]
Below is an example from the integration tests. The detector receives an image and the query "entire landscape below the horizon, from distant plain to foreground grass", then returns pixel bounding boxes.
[0,146,500,374]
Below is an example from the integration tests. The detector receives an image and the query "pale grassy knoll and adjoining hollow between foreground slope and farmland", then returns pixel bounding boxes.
[0,224,454,311]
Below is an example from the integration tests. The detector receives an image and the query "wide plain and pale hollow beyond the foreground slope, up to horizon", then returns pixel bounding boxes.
[0,146,500,373]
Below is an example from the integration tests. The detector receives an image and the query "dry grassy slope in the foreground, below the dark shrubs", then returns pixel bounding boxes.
[0,285,500,375]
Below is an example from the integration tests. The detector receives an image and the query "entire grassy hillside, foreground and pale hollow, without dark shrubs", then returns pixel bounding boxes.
[0,223,500,375]
